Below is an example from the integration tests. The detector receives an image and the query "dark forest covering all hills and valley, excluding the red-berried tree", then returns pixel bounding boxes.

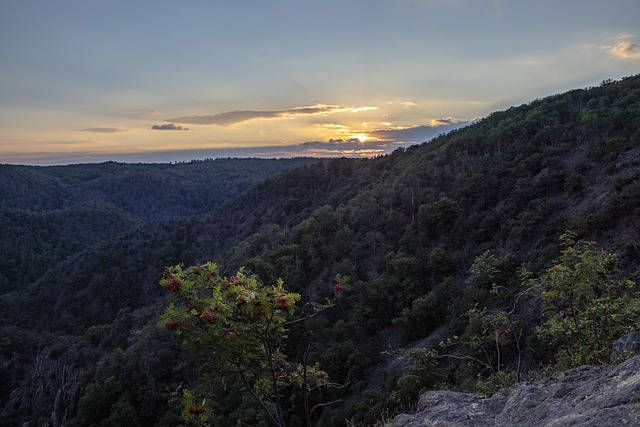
[0,76,640,426]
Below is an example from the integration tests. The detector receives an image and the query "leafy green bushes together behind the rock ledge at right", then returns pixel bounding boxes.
[448,232,640,395]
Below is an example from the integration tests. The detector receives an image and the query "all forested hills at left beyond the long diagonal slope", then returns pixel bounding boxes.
[0,158,315,292]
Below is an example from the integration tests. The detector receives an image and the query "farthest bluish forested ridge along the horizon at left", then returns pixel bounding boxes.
[0,158,317,220]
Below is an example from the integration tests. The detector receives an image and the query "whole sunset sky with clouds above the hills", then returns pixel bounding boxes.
[0,0,640,165]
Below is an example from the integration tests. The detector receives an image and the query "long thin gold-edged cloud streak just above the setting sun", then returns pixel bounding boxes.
[167,104,377,126]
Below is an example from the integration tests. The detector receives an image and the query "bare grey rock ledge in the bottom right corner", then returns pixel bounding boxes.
[391,356,640,427]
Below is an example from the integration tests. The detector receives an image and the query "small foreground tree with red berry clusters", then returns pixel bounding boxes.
[160,263,344,426]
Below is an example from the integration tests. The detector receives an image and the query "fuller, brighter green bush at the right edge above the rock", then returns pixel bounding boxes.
[529,232,640,368]
